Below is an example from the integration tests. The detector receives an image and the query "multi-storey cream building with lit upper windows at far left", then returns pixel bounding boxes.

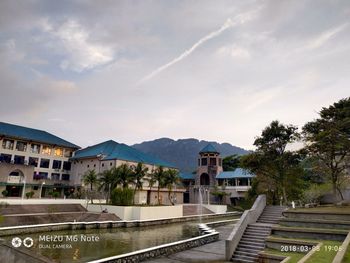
[0,122,80,197]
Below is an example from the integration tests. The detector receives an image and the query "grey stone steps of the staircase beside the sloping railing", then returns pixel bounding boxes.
[232,206,286,263]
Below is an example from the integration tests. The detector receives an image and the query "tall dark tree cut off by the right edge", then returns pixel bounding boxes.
[302,97,350,200]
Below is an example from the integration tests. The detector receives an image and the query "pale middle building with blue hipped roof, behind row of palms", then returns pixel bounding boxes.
[71,140,184,204]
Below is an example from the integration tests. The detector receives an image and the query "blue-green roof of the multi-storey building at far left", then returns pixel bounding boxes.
[0,122,80,149]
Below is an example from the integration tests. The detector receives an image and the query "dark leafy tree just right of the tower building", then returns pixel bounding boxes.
[241,121,303,203]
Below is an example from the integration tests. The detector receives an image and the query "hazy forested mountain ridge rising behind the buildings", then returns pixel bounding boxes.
[132,138,248,172]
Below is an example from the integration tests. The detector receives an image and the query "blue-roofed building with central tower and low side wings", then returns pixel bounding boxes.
[180,144,254,203]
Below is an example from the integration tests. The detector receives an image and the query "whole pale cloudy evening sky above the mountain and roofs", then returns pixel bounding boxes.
[0,0,350,149]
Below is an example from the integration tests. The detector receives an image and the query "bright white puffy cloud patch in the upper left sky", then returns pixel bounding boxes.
[42,19,114,72]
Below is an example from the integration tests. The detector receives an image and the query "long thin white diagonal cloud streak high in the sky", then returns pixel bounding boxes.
[138,8,260,84]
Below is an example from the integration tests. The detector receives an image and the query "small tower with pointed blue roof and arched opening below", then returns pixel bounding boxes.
[195,143,223,188]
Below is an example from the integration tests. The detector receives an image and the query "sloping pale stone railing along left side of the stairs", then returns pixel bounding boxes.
[225,195,266,260]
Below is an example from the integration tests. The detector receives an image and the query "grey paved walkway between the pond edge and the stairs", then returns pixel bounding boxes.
[146,224,234,263]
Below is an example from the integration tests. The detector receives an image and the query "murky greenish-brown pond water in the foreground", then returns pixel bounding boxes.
[5,223,199,263]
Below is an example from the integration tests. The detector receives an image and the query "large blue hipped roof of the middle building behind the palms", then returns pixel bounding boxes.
[72,140,176,168]
